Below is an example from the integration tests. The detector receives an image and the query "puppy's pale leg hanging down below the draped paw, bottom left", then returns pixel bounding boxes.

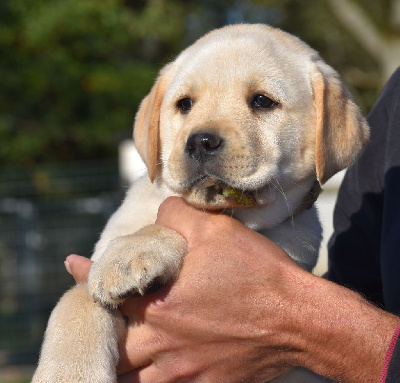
[32,284,125,383]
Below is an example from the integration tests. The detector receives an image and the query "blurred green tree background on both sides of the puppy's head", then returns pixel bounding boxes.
[0,0,400,168]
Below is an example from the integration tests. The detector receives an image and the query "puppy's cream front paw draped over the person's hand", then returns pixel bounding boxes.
[88,225,186,308]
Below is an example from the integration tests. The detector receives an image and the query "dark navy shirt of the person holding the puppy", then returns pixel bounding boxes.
[327,68,400,383]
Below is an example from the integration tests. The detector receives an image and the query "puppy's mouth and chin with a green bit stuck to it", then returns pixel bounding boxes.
[185,176,258,209]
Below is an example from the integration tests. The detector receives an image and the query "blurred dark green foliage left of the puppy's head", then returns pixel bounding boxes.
[0,0,192,165]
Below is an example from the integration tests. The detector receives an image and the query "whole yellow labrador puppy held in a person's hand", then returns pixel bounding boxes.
[33,25,369,383]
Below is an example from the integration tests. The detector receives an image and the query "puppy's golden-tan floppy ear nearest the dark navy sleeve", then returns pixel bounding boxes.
[311,60,369,184]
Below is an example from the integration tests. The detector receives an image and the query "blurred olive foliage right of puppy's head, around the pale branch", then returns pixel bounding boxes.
[253,0,392,108]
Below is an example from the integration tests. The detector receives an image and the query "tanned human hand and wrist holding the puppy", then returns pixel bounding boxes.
[67,198,398,383]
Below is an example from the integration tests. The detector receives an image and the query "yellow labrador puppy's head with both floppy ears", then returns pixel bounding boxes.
[134,25,369,222]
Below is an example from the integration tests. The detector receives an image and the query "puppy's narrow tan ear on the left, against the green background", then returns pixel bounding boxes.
[133,65,170,182]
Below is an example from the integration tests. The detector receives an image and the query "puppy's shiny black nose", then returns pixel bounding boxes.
[185,133,224,163]
